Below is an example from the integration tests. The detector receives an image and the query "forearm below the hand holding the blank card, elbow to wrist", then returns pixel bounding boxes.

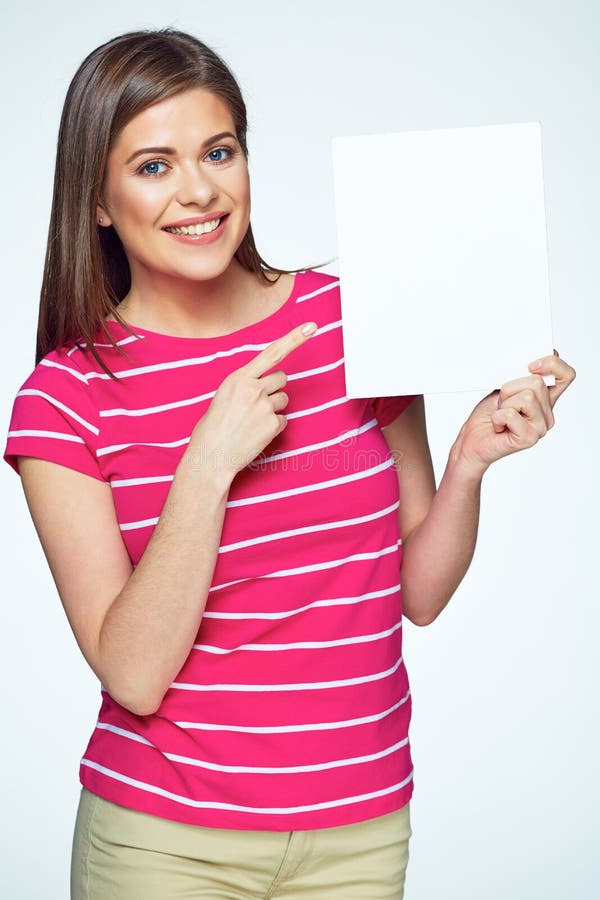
[401,444,483,625]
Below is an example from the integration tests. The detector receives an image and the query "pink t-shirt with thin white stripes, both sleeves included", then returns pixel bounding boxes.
[4,270,414,831]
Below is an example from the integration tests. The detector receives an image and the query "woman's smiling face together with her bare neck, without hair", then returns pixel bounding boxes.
[97,88,255,334]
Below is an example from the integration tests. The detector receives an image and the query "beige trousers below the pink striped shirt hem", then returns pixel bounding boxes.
[71,788,412,900]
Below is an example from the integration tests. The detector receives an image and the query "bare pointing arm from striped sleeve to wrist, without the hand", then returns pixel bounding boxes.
[19,454,234,715]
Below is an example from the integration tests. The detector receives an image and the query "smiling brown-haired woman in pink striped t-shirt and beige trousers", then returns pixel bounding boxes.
[4,30,575,900]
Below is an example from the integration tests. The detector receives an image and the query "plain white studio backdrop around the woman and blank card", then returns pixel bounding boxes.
[0,0,600,900]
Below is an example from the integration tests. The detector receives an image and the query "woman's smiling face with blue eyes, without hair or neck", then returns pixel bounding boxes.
[98,88,250,286]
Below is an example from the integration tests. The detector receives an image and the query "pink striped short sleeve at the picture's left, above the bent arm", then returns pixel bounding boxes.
[4,350,106,481]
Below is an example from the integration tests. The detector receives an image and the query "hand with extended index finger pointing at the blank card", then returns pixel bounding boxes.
[186,322,317,480]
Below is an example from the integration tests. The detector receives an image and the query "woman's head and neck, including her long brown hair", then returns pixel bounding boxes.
[36,29,310,377]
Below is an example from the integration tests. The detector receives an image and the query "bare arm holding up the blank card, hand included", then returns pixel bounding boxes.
[382,351,575,625]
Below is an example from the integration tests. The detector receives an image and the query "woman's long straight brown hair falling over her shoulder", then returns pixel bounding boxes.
[36,28,328,381]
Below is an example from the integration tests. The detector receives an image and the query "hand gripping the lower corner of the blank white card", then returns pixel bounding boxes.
[452,350,576,475]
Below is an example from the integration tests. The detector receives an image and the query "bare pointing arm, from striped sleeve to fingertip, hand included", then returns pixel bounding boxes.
[19,324,317,715]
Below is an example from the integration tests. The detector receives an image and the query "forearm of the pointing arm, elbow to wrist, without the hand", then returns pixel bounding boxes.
[98,448,231,715]
